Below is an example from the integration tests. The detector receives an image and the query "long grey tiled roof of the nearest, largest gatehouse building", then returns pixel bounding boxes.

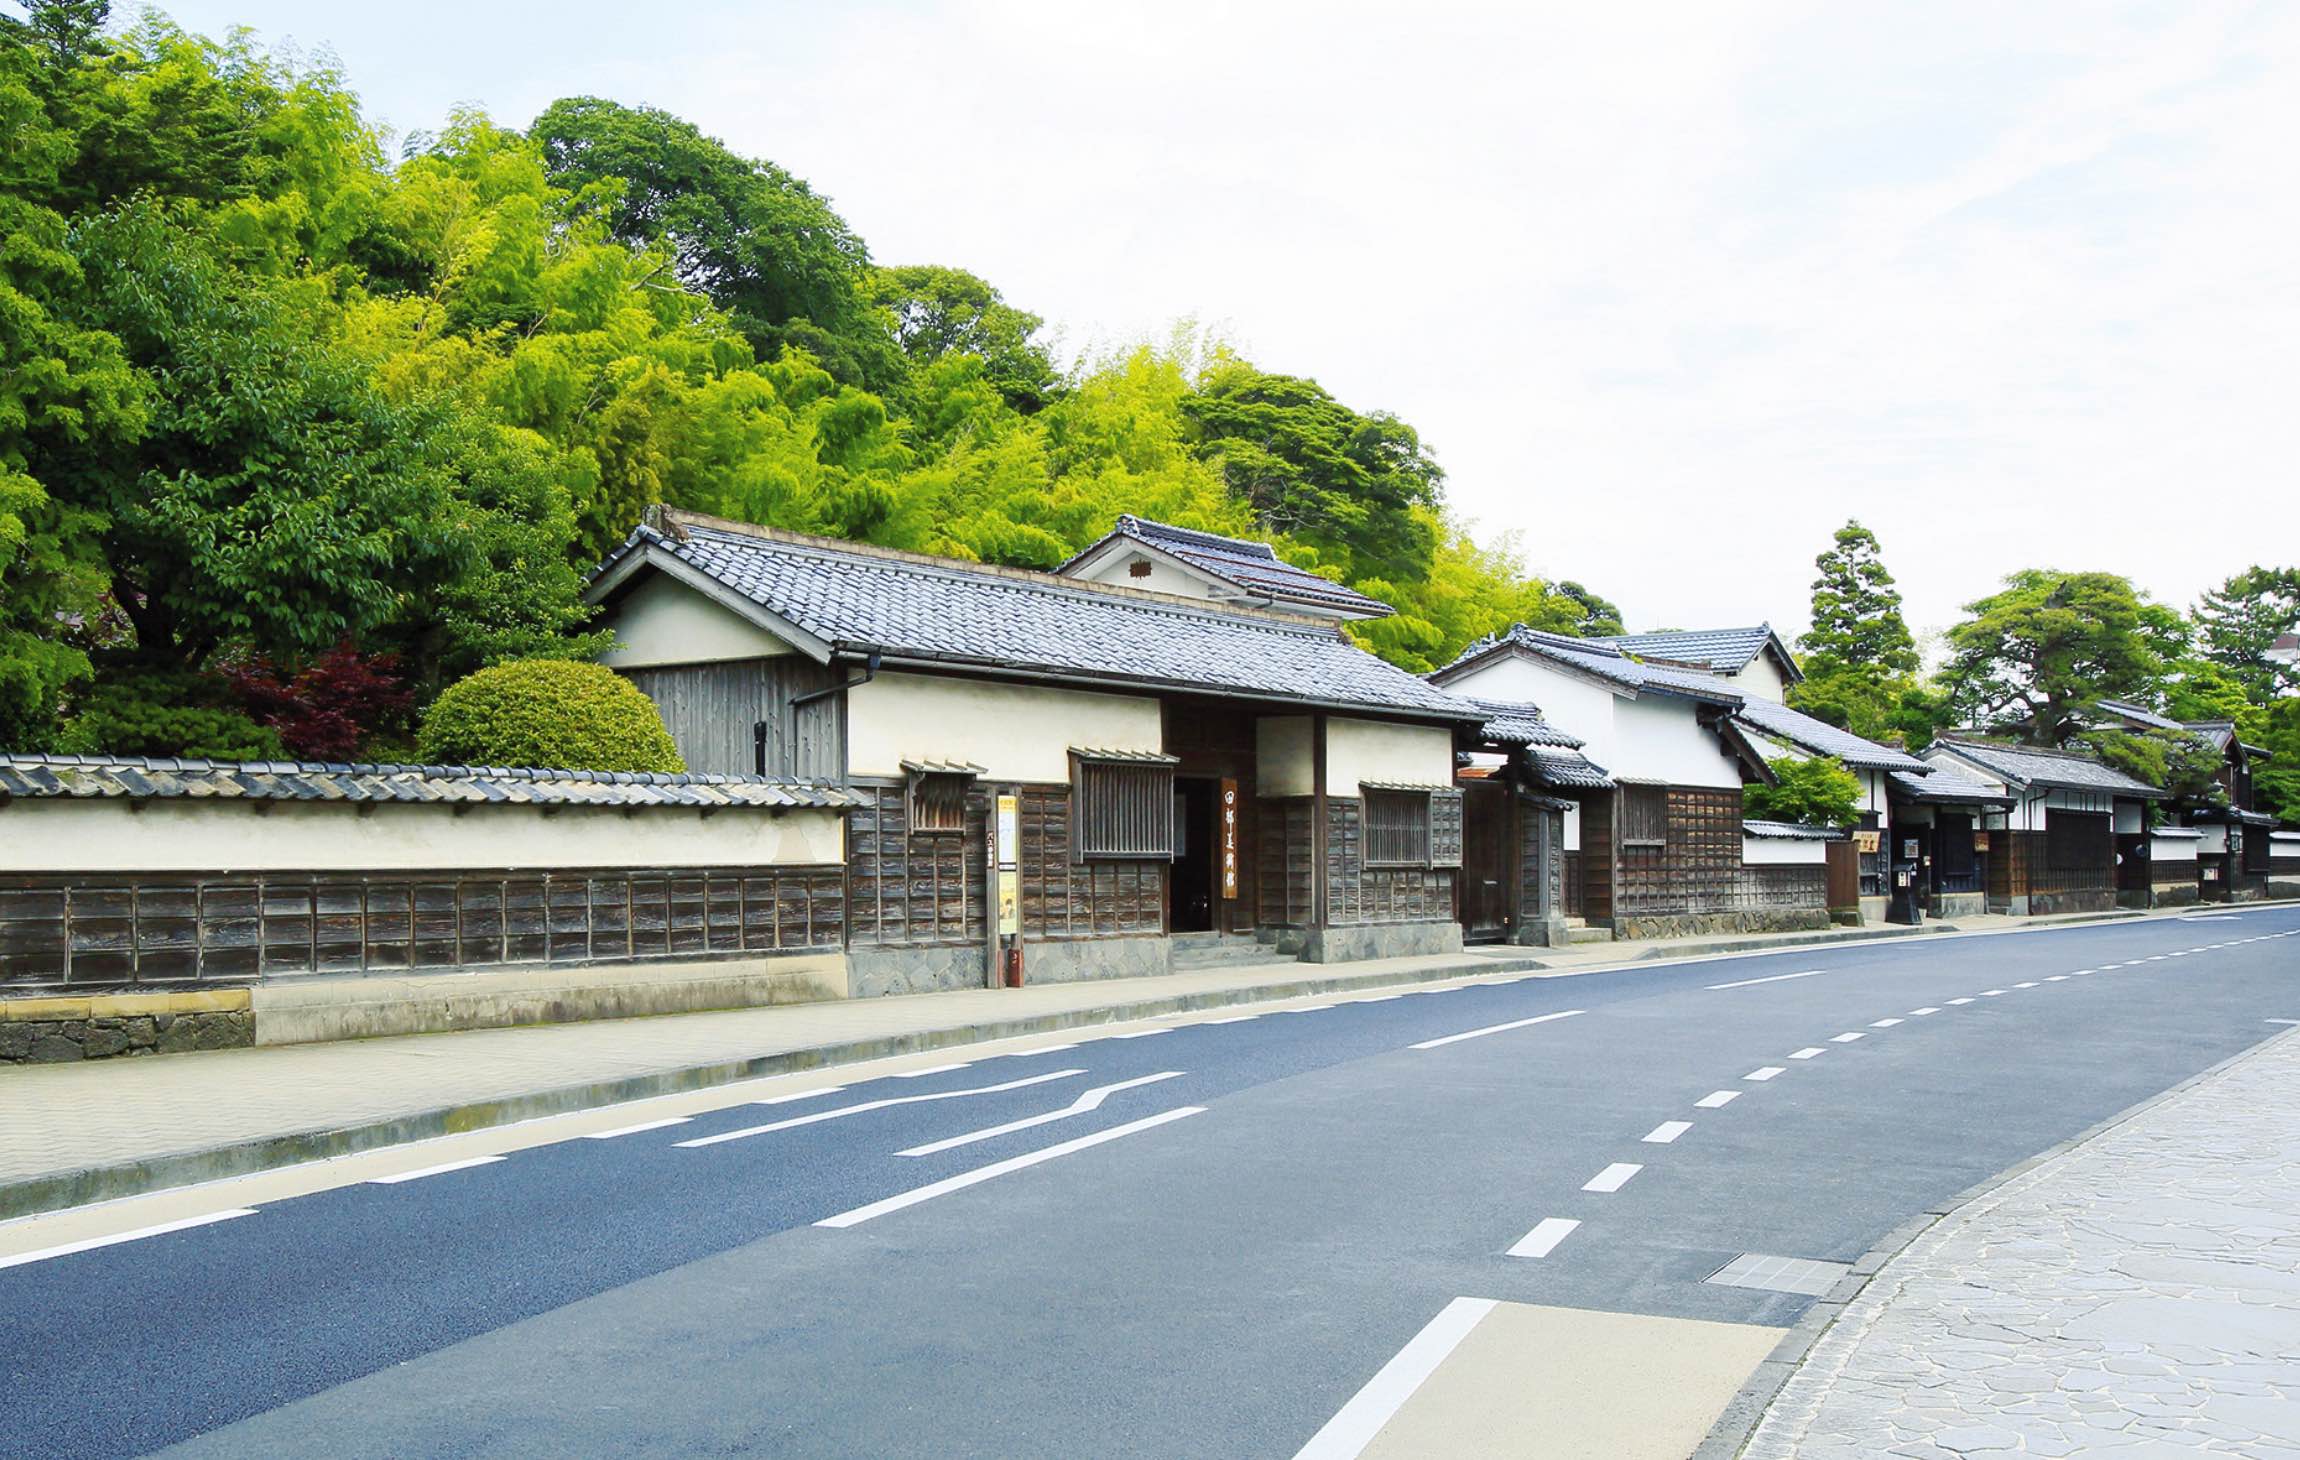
[591,517,1477,722]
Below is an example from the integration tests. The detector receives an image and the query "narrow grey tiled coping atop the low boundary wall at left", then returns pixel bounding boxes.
[0,754,863,807]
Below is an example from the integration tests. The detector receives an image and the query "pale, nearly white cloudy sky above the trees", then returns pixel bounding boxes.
[148,0,2300,632]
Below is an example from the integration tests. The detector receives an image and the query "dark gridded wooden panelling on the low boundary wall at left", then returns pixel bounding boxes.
[0,865,846,993]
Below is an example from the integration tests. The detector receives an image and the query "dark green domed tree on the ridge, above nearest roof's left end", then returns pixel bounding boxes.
[531,97,902,391]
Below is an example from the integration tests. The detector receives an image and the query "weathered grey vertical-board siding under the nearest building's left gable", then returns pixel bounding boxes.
[623,655,846,782]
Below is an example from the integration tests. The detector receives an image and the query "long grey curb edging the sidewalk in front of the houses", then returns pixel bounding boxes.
[0,956,1541,1221]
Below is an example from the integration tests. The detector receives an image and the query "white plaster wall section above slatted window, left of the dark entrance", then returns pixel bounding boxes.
[846,674,1164,782]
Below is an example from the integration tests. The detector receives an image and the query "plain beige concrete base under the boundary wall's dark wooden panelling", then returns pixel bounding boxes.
[251,952,846,1044]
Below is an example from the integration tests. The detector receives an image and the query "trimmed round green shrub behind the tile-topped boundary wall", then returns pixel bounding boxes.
[416,660,688,770]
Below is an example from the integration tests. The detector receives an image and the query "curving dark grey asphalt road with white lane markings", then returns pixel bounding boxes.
[0,908,2300,1455]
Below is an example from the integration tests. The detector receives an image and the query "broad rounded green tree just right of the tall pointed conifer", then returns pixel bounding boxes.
[1941,568,2183,745]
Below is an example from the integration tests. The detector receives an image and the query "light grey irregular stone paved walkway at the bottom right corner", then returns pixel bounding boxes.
[1743,1030,2300,1460]
